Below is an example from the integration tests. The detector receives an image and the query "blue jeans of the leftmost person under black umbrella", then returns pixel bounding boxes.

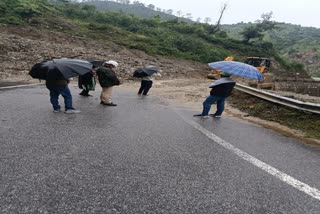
[47,86,73,110]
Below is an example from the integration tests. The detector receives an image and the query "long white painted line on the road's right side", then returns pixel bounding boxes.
[176,111,320,200]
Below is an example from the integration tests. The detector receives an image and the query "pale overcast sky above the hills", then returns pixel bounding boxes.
[137,0,320,28]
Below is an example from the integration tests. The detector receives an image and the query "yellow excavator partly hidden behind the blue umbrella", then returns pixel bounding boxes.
[207,56,271,79]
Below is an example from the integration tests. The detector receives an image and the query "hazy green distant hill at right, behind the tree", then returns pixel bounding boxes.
[221,23,320,76]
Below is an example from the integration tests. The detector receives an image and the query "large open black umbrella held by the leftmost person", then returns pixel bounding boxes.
[29,58,93,80]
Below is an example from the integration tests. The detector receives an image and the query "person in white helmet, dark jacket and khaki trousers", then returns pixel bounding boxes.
[96,60,120,106]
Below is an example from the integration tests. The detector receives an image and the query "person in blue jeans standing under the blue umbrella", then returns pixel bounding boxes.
[193,72,236,118]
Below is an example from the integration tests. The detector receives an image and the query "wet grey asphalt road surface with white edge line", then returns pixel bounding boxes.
[0,86,320,214]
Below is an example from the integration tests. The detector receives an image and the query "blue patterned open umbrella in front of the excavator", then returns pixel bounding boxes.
[208,61,263,80]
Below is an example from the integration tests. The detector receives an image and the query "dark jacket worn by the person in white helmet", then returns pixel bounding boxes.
[97,67,120,87]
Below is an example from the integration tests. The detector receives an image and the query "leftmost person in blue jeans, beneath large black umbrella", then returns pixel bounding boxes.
[46,70,81,114]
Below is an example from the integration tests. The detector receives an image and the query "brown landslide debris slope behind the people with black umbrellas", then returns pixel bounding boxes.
[0,26,210,80]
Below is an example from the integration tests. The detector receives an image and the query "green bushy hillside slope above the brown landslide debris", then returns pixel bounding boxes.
[0,0,312,72]
